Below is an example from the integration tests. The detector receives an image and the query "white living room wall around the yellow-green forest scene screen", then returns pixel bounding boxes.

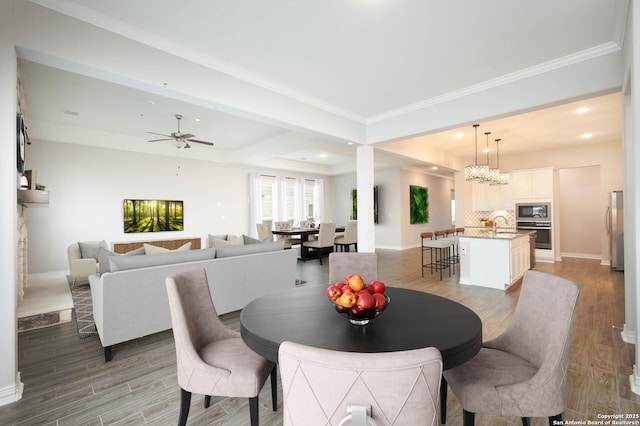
[26,141,331,274]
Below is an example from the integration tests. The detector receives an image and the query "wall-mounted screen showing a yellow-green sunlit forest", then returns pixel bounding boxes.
[123,200,184,234]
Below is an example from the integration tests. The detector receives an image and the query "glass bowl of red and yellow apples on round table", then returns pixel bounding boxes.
[326,274,391,325]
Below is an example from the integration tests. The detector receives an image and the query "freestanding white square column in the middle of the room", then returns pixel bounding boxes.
[356,145,376,253]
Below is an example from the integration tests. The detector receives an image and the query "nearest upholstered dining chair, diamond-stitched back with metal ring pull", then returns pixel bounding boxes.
[278,341,442,426]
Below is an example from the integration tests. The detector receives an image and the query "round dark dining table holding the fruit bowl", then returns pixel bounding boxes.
[240,285,482,370]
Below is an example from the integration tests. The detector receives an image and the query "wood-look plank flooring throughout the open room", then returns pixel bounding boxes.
[0,248,640,426]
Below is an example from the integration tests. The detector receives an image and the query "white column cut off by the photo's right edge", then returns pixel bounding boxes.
[623,3,640,394]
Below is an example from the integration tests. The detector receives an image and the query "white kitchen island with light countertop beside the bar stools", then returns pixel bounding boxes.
[459,229,530,290]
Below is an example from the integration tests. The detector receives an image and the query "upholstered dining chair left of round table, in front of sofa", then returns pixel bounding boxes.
[166,269,278,426]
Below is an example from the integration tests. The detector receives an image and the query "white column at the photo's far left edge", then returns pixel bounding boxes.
[0,2,22,405]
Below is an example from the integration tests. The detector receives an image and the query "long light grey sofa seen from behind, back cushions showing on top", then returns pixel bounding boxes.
[89,238,297,361]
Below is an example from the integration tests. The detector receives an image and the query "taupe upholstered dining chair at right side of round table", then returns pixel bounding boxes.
[440,271,580,426]
